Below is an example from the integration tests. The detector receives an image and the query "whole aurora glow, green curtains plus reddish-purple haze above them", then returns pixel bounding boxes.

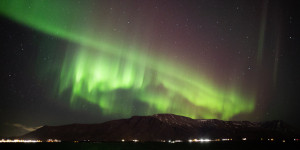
[0,0,300,136]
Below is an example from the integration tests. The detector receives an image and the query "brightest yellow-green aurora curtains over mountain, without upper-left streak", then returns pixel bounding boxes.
[60,49,254,119]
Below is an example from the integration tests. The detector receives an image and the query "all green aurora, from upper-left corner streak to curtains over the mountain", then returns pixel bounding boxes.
[0,0,255,120]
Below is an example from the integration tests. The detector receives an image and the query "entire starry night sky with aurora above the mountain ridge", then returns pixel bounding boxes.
[0,0,300,136]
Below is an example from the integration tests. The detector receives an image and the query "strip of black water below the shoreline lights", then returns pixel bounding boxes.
[0,142,300,150]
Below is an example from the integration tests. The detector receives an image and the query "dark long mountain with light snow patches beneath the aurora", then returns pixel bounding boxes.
[20,114,298,141]
